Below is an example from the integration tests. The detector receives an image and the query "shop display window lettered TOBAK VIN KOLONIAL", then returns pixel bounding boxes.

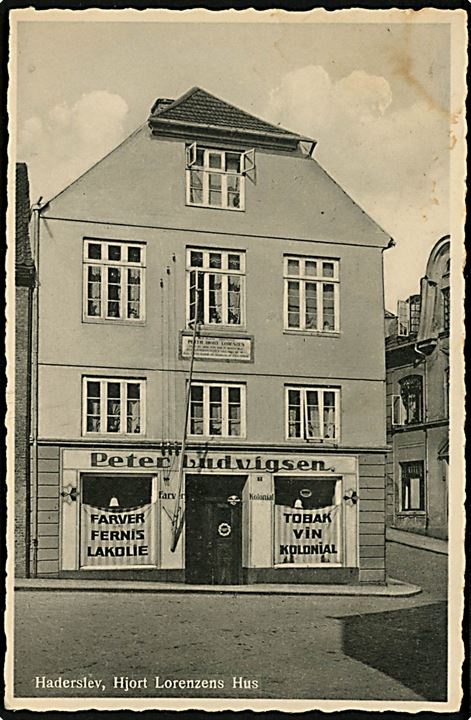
[274,476,343,567]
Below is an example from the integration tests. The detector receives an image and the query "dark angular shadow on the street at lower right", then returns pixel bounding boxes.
[338,602,447,701]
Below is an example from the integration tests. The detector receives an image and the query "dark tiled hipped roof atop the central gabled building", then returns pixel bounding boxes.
[149,87,310,142]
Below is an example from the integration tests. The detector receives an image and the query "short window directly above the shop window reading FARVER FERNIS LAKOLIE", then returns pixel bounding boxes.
[83,377,145,435]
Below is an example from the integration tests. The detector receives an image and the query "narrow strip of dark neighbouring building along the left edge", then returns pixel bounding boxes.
[14,163,35,577]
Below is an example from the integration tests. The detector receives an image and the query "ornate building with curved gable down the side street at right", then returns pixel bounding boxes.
[386,235,450,539]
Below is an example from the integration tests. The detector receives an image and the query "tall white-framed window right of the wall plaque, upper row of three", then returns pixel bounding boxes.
[284,256,339,332]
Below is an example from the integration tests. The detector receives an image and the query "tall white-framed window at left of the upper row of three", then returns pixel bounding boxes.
[84,240,145,322]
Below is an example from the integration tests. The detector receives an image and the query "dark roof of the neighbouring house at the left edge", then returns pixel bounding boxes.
[15,163,34,285]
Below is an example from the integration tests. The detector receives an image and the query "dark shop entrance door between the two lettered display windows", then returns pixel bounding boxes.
[185,478,242,585]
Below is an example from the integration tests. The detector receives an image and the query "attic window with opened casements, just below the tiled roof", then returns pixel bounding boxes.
[186,143,255,210]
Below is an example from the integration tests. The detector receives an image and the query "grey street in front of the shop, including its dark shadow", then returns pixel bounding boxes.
[10,544,447,700]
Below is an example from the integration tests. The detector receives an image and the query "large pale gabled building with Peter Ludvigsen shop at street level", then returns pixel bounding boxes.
[27,88,390,584]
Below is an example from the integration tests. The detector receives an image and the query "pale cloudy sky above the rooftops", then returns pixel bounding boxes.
[15,11,453,311]
